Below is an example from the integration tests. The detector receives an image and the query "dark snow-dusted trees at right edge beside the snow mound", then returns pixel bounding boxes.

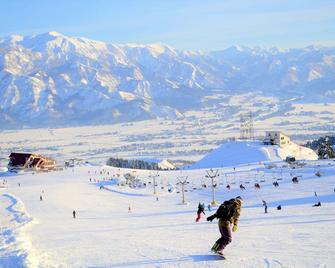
[306,136,335,159]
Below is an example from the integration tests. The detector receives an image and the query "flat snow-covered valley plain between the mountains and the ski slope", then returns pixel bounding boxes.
[0,105,335,166]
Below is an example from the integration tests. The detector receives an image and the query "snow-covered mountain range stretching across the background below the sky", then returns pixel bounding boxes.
[0,32,335,129]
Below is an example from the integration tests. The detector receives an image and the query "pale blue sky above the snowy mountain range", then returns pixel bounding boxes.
[0,0,335,50]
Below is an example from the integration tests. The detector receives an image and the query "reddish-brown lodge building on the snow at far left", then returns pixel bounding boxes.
[8,153,56,171]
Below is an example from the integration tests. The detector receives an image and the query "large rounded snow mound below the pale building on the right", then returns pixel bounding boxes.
[191,141,318,169]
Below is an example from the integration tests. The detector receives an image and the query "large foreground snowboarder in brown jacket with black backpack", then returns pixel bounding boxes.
[207,196,242,255]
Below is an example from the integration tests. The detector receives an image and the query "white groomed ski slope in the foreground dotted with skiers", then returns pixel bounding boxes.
[0,161,335,268]
